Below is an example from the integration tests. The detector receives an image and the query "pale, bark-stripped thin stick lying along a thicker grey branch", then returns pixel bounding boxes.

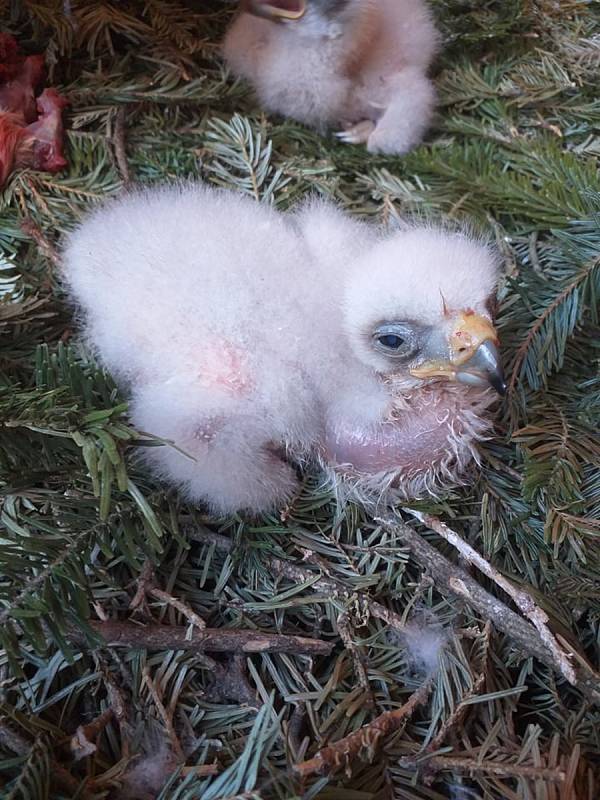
[404,509,577,686]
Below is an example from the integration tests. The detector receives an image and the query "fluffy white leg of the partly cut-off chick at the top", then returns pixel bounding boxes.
[367,68,435,154]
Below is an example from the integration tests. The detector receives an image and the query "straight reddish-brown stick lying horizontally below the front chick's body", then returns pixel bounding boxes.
[70,620,333,655]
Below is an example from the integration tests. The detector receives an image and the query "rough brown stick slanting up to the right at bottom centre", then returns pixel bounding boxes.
[294,680,432,778]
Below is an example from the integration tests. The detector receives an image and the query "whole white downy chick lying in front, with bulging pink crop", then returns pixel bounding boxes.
[64,185,503,513]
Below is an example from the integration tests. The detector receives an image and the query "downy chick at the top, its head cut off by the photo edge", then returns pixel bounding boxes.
[223,0,439,153]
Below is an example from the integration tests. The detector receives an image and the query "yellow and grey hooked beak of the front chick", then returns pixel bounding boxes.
[410,311,506,395]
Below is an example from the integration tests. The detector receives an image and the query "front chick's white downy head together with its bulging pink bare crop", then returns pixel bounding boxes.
[324,228,505,497]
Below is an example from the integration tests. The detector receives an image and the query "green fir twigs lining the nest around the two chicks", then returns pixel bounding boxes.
[0,0,600,800]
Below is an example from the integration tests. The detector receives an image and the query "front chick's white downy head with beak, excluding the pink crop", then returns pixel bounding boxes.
[345,228,505,394]
